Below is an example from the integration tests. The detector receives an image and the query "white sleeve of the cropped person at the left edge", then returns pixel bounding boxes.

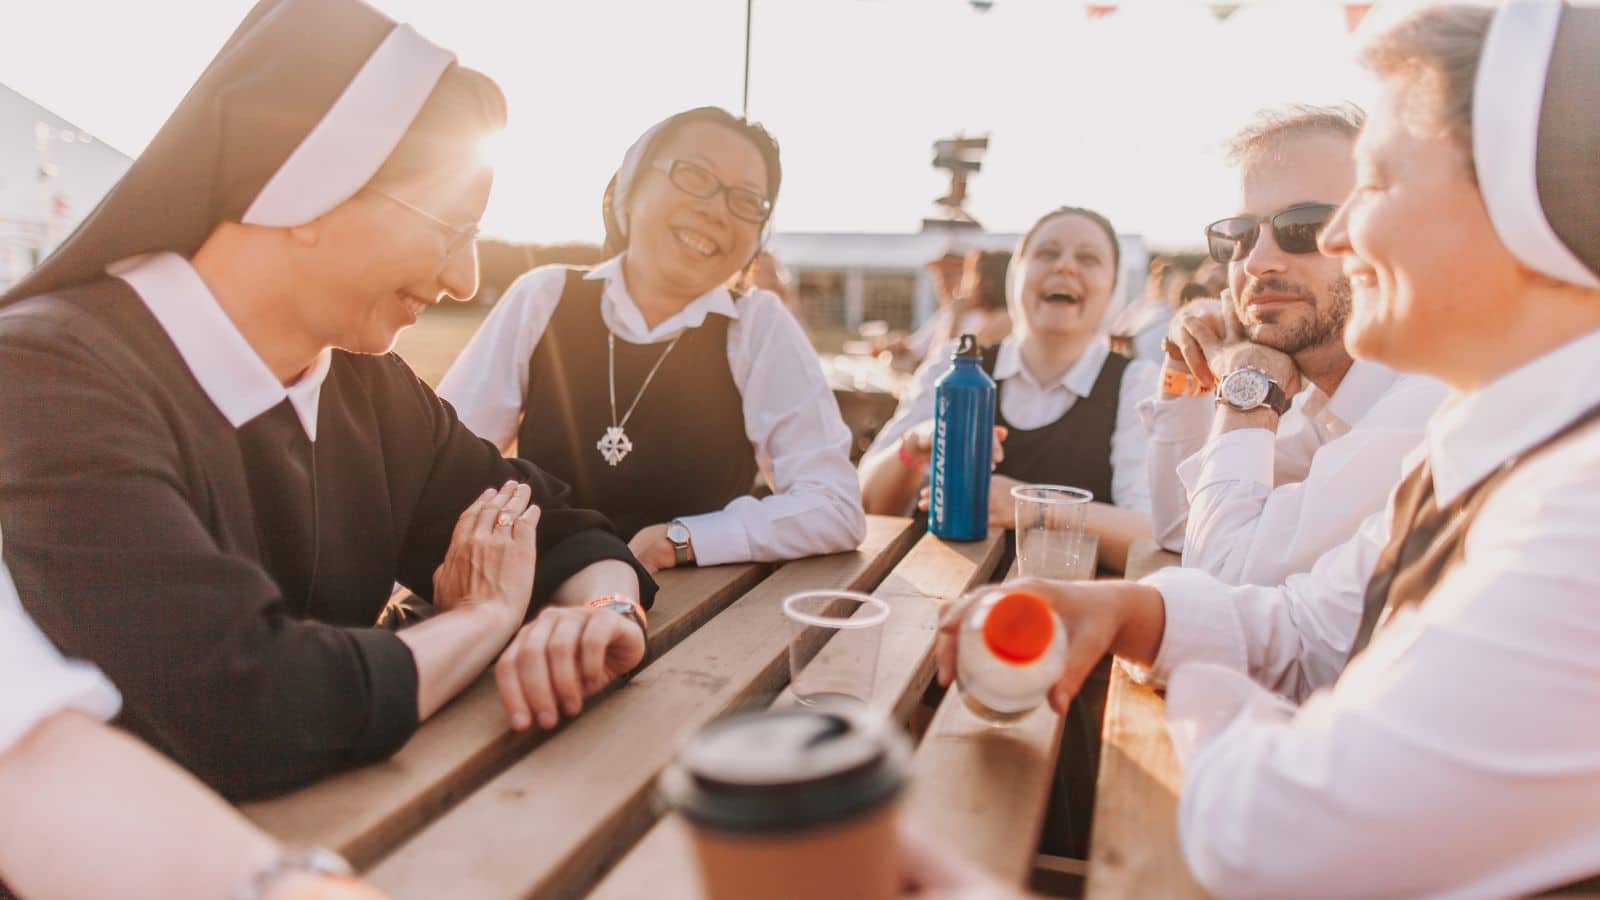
[0,567,122,753]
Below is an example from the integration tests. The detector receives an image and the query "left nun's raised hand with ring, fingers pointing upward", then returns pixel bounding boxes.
[434,480,539,624]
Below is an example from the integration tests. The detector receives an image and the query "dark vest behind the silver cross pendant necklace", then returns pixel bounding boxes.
[517,269,757,538]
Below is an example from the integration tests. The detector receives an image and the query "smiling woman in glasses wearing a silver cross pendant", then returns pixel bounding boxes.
[438,107,866,572]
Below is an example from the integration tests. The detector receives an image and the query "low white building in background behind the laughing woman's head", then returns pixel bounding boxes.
[771,229,1149,331]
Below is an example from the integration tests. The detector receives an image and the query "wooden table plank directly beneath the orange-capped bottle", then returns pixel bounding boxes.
[902,535,1099,886]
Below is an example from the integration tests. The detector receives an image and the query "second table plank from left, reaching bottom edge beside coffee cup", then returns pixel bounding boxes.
[370,517,920,900]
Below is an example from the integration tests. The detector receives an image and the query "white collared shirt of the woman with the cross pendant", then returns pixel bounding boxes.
[438,256,867,565]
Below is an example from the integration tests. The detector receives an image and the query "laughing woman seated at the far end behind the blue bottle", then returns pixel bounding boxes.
[861,207,1157,570]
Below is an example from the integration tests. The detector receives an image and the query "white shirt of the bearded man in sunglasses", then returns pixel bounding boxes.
[1139,360,1448,585]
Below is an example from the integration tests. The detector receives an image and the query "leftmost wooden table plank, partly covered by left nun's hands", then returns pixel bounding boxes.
[243,565,771,866]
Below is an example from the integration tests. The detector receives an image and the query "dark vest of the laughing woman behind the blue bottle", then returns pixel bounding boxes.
[984,344,1128,503]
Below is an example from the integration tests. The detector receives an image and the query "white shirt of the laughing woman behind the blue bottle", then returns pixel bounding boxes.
[869,336,1160,511]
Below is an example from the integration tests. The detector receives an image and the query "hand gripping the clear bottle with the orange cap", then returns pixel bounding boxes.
[933,578,1132,713]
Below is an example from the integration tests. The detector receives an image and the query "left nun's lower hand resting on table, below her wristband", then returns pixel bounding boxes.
[494,607,645,732]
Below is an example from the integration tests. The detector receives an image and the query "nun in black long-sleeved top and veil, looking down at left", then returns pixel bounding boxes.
[0,0,654,798]
